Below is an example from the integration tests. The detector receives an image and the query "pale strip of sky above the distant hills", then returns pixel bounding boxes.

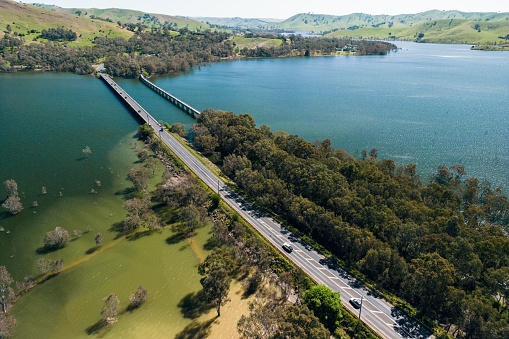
[30,0,509,19]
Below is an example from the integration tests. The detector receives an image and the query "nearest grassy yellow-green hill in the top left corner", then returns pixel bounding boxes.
[0,0,133,45]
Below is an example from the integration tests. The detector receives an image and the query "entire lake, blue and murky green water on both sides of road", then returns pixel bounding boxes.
[0,39,509,338]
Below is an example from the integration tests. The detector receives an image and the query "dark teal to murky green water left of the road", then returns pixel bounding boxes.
[0,73,214,338]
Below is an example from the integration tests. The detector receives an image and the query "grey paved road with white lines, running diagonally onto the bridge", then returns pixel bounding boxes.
[103,76,433,339]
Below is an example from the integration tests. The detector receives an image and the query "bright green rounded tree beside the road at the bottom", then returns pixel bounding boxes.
[302,285,343,332]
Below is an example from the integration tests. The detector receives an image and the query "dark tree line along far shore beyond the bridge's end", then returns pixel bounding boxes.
[0,25,396,78]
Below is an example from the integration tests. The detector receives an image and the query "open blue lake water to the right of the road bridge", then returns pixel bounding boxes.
[115,42,509,189]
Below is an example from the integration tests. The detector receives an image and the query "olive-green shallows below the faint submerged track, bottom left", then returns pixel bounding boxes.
[13,228,213,338]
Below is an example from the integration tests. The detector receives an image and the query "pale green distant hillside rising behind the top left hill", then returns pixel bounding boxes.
[37,5,210,30]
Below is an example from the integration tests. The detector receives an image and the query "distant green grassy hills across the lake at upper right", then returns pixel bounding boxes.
[278,10,509,44]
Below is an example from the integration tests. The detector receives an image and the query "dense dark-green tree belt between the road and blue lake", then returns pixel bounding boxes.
[191,110,509,338]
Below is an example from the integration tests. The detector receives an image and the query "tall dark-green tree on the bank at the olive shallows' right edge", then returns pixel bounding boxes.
[200,268,231,317]
